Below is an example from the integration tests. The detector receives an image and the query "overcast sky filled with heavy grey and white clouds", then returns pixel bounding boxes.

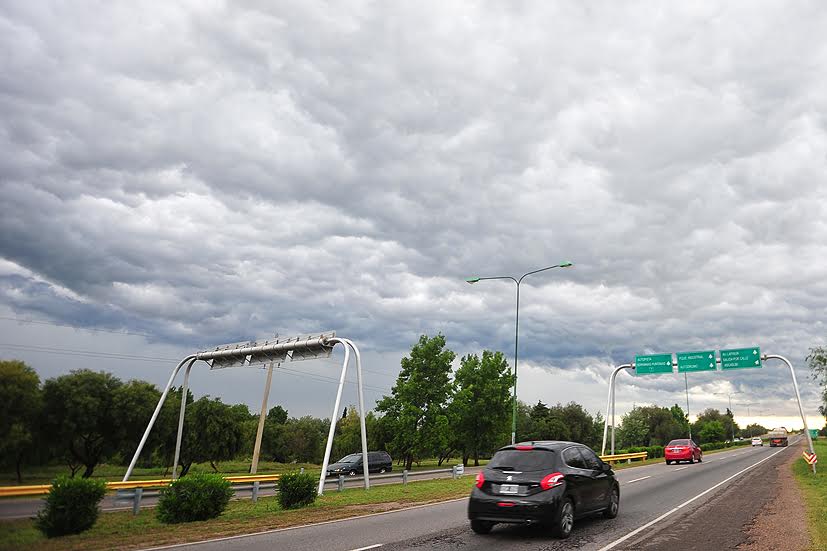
[0,0,827,427]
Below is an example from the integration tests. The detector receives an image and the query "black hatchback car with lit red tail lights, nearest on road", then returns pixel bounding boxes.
[468,441,620,538]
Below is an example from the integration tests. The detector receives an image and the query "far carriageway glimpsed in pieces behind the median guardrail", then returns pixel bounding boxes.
[0,467,480,520]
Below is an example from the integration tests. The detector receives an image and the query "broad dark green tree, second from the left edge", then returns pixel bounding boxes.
[43,369,123,478]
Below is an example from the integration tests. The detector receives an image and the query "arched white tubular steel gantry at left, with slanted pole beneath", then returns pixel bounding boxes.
[123,333,370,494]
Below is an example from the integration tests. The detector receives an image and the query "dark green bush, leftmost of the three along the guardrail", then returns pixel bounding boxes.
[35,476,106,538]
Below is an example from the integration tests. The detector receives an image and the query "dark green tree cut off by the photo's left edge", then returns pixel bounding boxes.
[0,360,43,483]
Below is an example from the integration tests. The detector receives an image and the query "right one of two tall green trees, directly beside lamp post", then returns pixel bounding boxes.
[449,350,514,466]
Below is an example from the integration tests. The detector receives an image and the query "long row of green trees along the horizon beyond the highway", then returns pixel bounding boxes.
[0,334,796,480]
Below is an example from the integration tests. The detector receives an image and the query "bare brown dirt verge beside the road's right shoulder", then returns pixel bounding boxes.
[737,446,812,551]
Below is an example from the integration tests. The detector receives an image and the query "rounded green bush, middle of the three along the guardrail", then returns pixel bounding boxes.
[155,473,233,524]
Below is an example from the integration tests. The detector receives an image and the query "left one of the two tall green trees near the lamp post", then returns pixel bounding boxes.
[376,334,456,469]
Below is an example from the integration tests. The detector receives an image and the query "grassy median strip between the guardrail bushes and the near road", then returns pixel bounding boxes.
[0,475,474,551]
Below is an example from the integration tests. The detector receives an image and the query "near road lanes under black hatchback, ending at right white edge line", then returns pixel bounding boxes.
[152,446,800,551]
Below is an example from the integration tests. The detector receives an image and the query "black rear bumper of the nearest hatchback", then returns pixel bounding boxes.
[468,488,562,524]
